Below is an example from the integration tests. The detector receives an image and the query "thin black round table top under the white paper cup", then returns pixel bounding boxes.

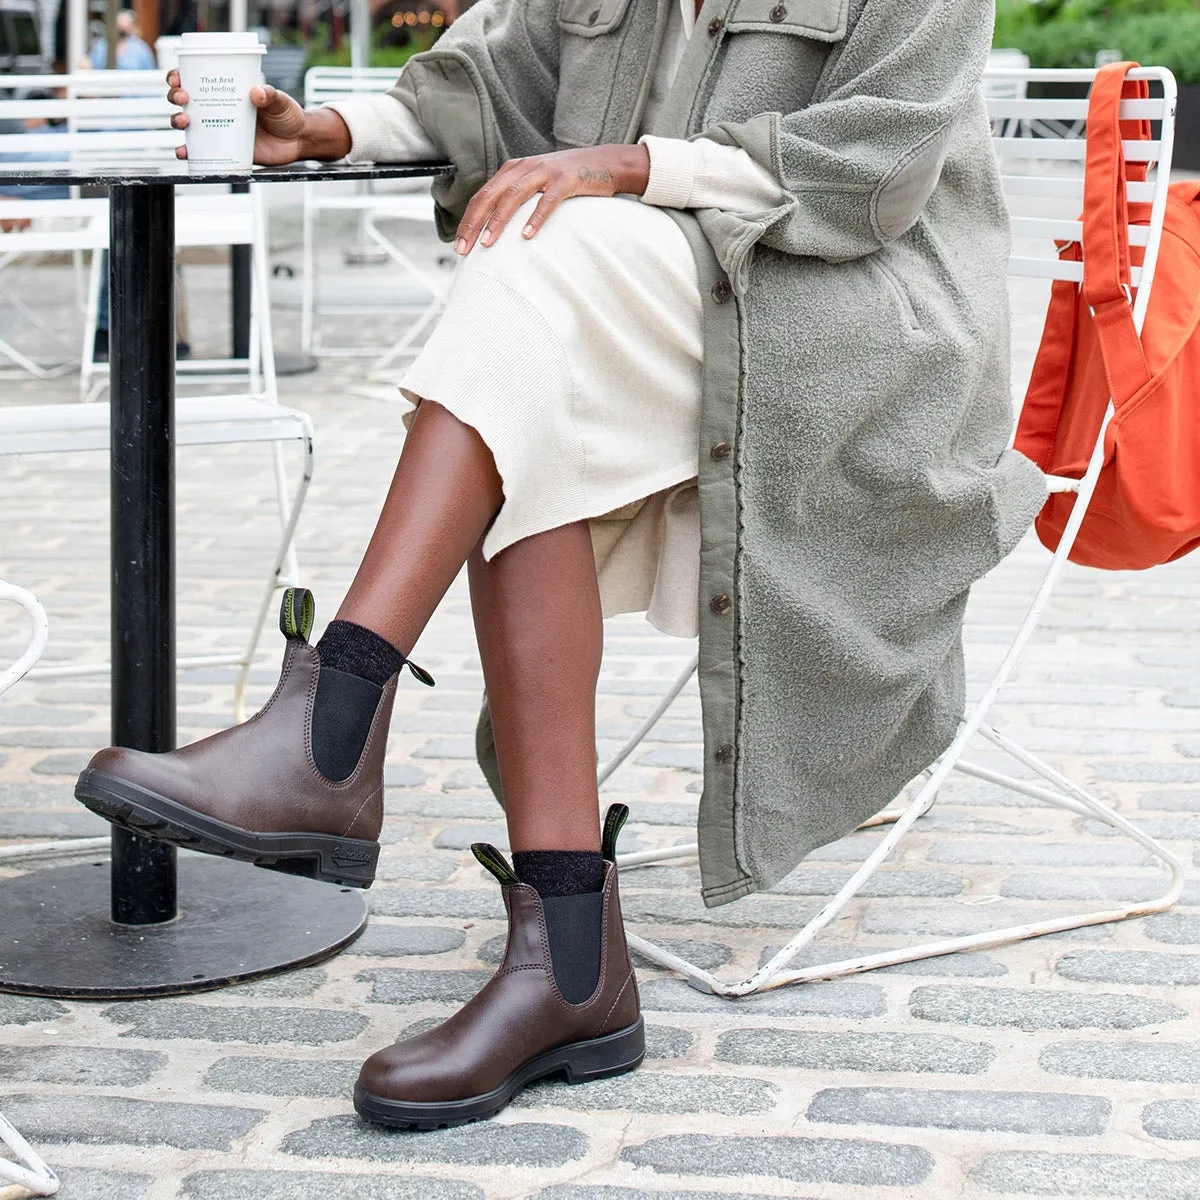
[0,160,454,187]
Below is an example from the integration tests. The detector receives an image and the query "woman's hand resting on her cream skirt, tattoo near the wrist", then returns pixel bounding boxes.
[454,145,650,254]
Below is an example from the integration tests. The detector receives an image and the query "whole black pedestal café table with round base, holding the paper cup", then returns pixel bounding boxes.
[0,162,450,998]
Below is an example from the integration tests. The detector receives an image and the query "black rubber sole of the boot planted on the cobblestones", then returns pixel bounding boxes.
[354,1016,646,1129]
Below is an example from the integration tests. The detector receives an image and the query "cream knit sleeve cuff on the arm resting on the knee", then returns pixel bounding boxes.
[641,134,784,212]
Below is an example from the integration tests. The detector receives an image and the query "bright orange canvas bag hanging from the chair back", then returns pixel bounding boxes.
[1015,62,1200,570]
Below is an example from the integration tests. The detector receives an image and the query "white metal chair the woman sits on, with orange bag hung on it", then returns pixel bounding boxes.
[614,67,1183,997]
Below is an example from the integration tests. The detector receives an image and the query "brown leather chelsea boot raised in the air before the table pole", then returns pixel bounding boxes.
[76,588,432,888]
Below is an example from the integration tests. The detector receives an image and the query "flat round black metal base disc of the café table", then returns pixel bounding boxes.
[0,854,367,1000]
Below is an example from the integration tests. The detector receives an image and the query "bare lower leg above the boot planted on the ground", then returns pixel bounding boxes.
[469,521,604,851]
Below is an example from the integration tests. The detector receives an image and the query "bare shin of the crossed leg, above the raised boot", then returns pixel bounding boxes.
[337,400,504,654]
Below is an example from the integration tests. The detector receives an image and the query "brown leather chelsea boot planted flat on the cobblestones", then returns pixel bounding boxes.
[354,804,646,1129]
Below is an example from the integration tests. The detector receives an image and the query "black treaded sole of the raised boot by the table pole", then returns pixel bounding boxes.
[76,769,379,888]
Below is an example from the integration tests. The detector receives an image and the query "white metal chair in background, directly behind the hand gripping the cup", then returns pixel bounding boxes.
[300,67,448,364]
